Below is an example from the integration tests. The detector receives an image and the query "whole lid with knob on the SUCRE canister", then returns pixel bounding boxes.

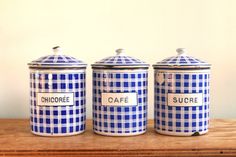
[153,48,211,69]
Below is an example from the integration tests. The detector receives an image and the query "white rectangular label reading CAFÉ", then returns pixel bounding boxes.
[102,93,138,106]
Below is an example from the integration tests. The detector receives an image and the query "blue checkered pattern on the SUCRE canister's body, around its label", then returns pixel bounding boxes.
[154,70,209,135]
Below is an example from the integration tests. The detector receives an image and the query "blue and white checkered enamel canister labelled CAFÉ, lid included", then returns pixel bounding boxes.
[92,49,149,136]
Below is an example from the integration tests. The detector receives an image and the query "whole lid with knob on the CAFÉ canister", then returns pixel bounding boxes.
[92,49,149,68]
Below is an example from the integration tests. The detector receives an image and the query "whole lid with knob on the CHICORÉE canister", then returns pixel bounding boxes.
[28,46,87,68]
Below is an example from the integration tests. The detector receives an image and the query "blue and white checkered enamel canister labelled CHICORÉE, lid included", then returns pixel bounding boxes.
[28,46,86,136]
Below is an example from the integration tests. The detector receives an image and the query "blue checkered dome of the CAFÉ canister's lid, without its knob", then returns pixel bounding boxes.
[95,55,148,65]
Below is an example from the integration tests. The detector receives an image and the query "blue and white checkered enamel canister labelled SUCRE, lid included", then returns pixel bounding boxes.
[153,48,211,136]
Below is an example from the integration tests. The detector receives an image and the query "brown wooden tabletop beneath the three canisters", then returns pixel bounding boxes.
[0,119,236,157]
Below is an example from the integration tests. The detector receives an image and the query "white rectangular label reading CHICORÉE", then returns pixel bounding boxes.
[37,93,74,106]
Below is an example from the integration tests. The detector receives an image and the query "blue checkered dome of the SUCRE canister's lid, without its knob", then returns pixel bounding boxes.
[155,55,209,66]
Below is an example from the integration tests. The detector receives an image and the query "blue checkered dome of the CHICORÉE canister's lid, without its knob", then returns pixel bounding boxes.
[30,55,86,66]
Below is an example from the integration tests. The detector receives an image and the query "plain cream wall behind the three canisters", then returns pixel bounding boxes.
[0,0,236,118]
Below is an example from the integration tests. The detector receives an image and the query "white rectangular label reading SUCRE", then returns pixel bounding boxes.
[167,93,203,106]
